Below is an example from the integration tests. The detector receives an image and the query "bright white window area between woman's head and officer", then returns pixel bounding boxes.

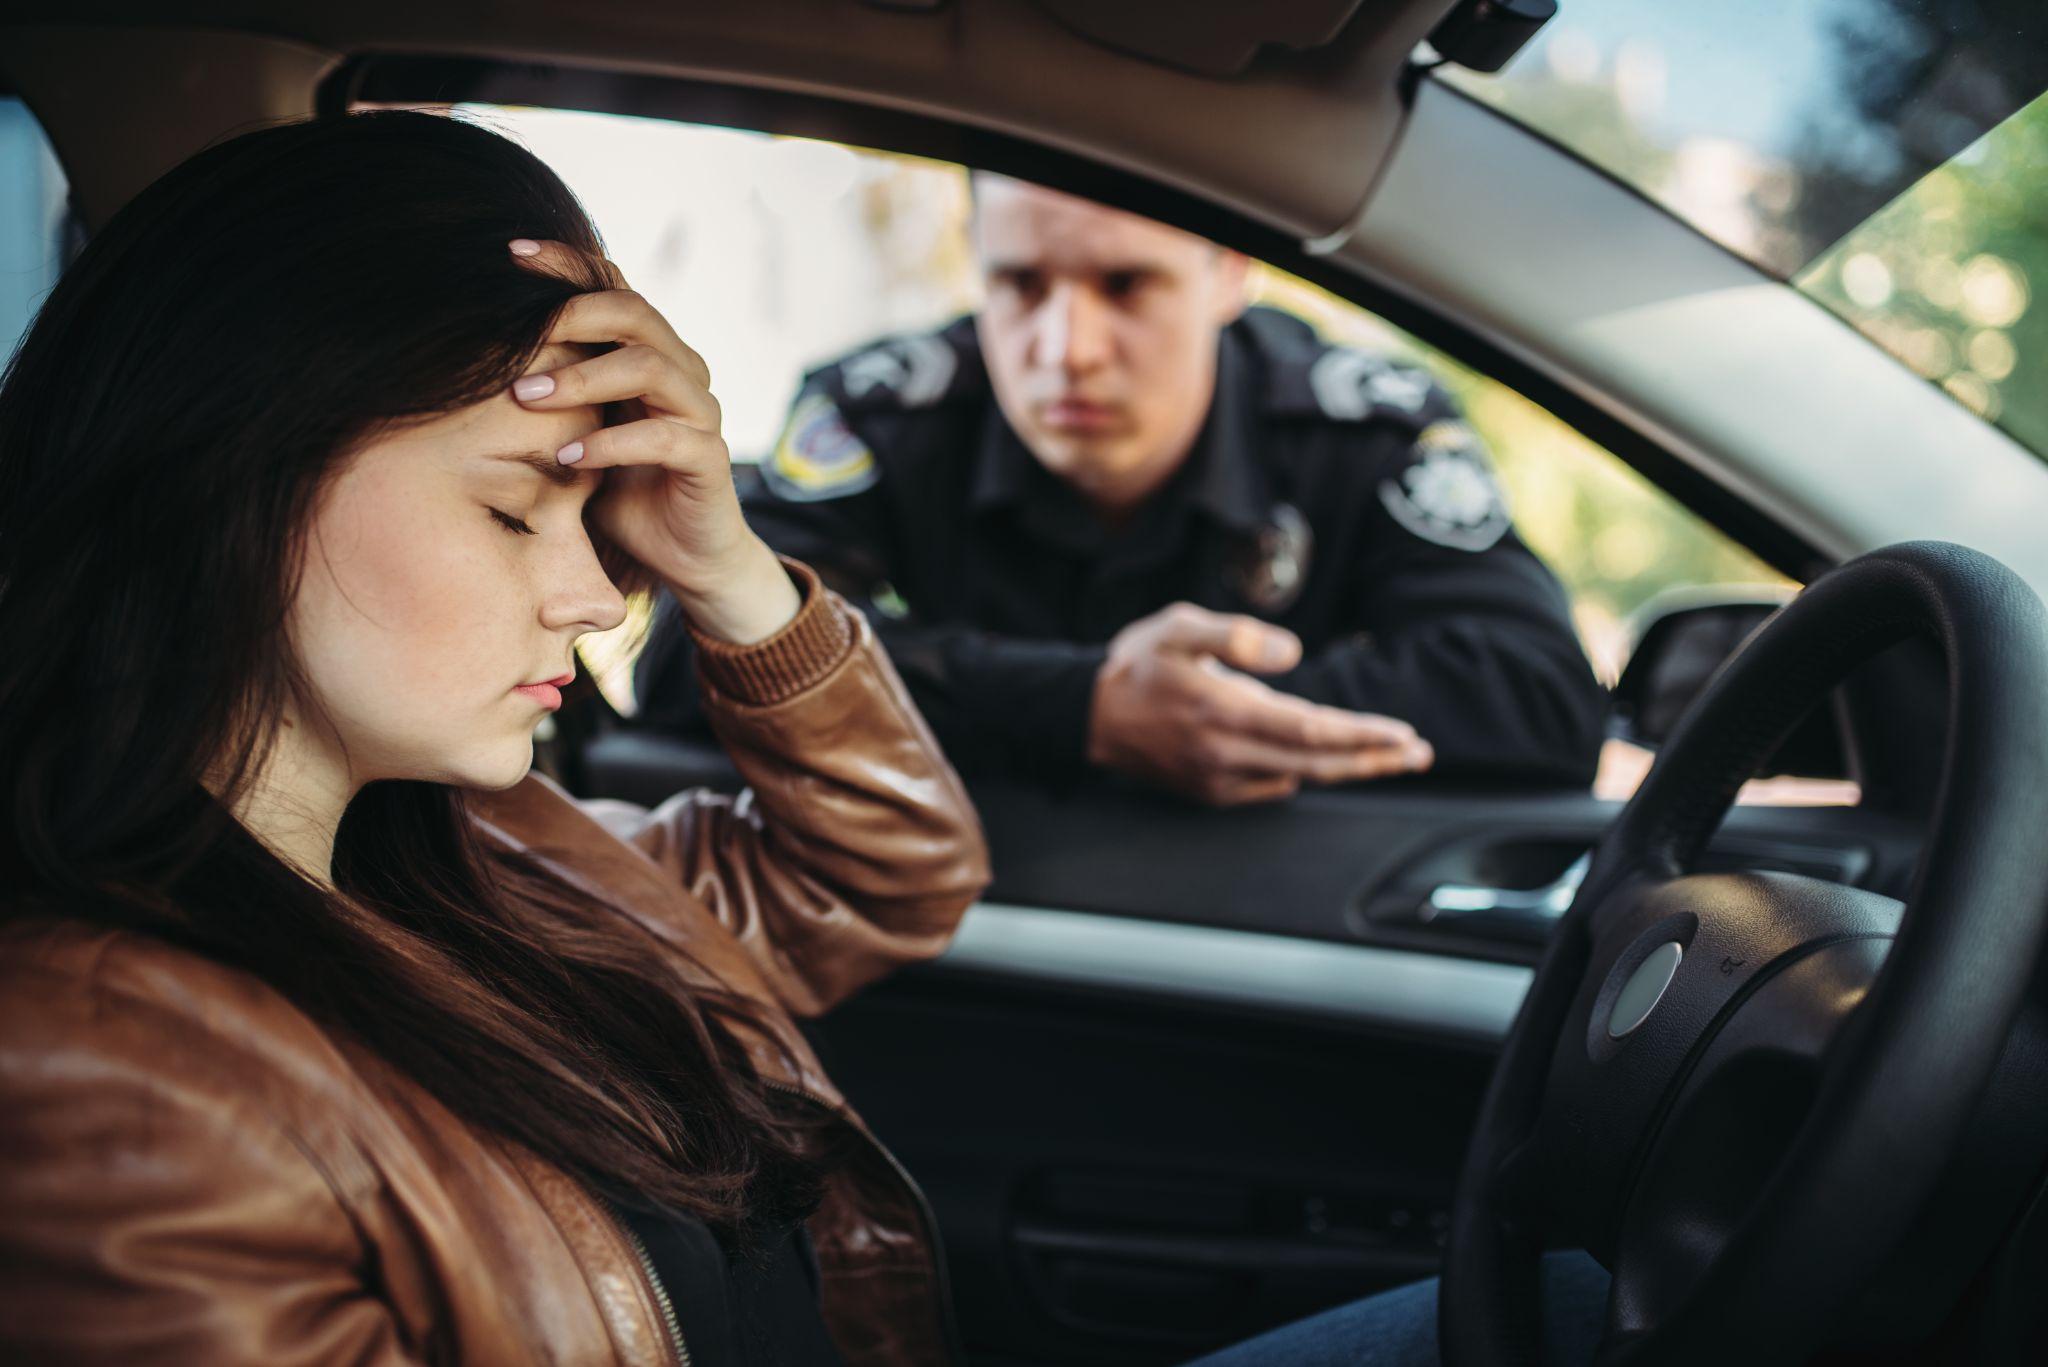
[438,105,975,461]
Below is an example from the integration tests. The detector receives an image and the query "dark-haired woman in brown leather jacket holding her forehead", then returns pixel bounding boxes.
[0,113,987,1365]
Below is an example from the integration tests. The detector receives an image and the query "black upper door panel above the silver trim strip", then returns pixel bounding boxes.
[580,730,1919,963]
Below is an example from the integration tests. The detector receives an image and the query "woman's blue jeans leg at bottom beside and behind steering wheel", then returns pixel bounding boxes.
[1188,1252,1608,1367]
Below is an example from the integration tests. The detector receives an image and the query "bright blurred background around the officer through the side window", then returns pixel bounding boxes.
[391,105,1818,803]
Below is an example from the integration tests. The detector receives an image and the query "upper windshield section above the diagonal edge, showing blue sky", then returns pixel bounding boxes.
[1438,0,2048,277]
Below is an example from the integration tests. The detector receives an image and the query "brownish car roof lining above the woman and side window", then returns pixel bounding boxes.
[0,0,1452,238]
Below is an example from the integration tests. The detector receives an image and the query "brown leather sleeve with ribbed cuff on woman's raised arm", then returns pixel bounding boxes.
[580,560,989,1014]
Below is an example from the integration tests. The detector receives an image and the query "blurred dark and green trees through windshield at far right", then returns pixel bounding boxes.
[1794,0,2048,455]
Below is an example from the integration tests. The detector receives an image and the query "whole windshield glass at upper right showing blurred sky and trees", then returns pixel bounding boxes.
[1440,0,2048,455]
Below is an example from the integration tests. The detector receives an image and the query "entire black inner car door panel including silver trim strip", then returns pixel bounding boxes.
[580,728,1917,1367]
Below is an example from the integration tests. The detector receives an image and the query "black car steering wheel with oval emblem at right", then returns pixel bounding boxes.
[1438,541,2048,1367]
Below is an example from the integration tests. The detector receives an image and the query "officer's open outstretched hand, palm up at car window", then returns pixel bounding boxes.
[1087,603,1436,807]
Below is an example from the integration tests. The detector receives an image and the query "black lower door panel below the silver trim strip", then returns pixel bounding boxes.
[809,959,1490,1363]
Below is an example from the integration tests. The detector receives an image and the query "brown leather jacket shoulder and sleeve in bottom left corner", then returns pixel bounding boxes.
[0,928,422,1367]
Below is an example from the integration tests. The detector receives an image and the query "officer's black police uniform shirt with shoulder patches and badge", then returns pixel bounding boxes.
[635,307,1606,783]
